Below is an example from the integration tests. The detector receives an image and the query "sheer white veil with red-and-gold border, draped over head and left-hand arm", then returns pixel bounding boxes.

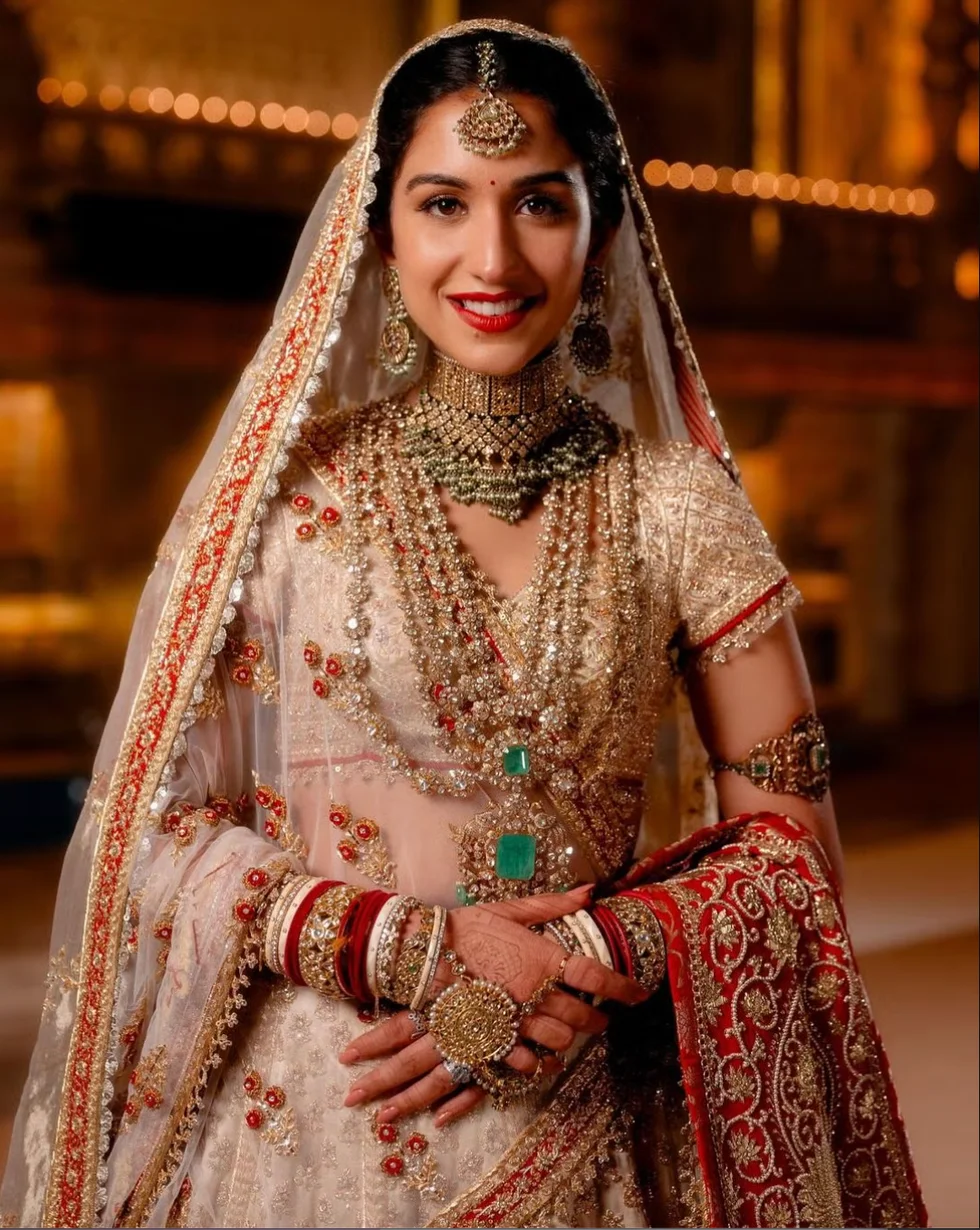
[0,22,735,1226]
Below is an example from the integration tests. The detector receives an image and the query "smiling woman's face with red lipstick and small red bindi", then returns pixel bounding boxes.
[386,91,590,375]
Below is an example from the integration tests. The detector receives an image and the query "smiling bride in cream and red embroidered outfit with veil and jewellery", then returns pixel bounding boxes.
[2,21,925,1226]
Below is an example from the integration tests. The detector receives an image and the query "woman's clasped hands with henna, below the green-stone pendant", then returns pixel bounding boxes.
[339,886,647,1127]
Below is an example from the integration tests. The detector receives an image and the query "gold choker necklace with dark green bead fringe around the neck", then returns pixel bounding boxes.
[402,349,617,524]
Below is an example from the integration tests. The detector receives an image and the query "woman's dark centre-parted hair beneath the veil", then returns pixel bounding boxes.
[369,31,623,236]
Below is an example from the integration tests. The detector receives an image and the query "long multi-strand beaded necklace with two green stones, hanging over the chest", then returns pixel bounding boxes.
[302,402,638,900]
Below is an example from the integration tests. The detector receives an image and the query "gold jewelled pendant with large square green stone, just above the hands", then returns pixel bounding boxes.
[449,792,574,905]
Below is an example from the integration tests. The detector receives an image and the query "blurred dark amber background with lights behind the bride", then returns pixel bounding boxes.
[0,0,980,1226]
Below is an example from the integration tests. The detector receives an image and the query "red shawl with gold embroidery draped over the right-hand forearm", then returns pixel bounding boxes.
[433,813,926,1226]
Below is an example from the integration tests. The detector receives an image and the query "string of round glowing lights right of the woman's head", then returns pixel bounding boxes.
[643,159,936,218]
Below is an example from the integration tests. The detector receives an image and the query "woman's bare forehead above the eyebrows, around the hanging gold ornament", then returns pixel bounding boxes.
[398,90,579,182]
